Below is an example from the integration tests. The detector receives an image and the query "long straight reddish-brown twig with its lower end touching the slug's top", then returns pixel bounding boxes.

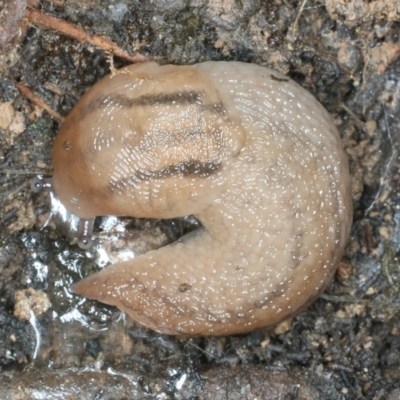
[26,8,149,62]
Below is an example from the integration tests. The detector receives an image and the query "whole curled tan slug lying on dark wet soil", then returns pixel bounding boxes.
[53,62,352,335]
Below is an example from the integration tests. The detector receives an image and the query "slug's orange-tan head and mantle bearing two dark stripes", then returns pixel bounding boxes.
[53,63,245,219]
